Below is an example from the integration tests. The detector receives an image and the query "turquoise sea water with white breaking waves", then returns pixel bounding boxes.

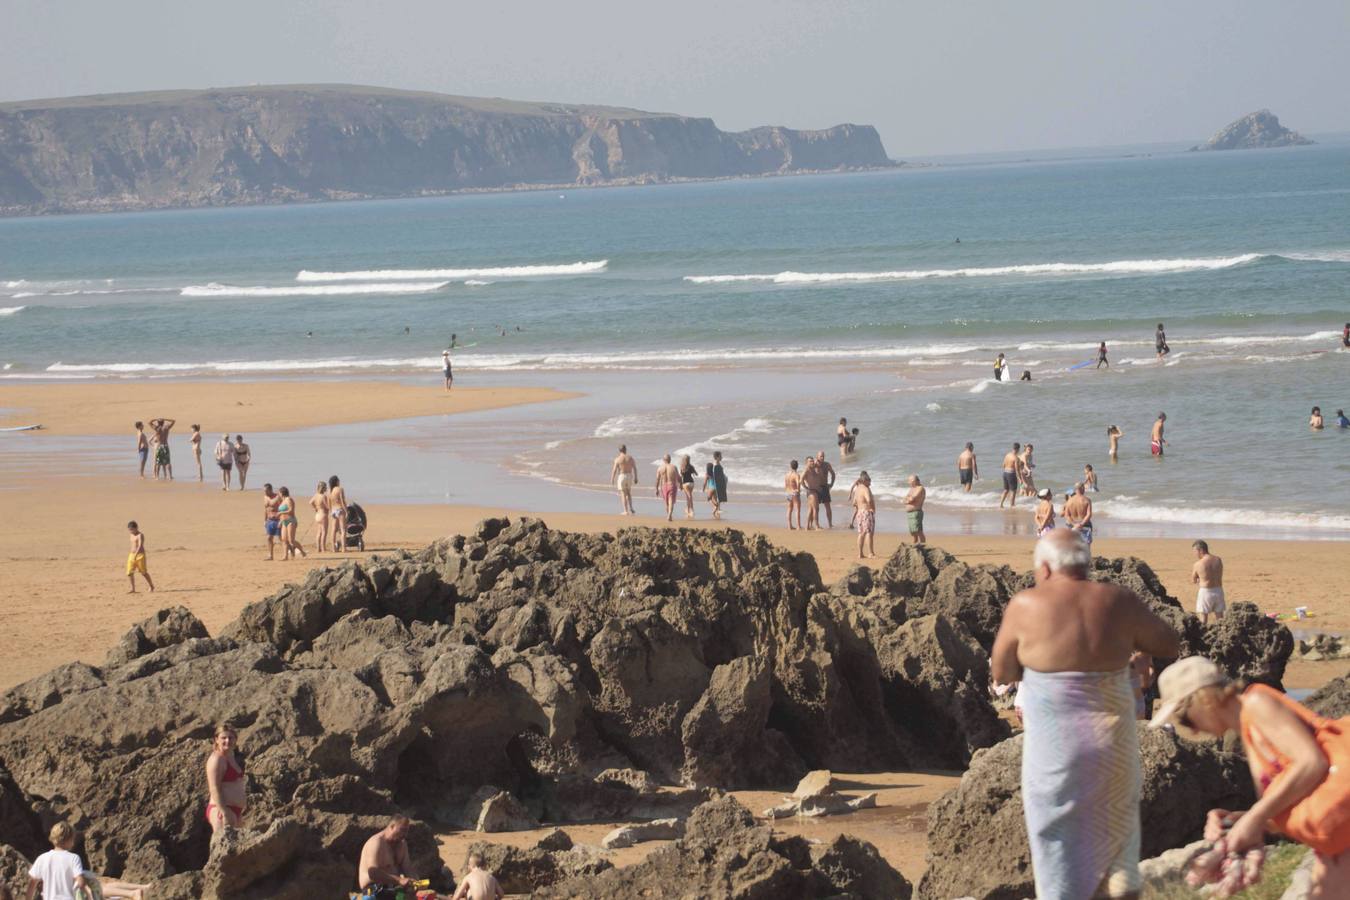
[0,140,1350,537]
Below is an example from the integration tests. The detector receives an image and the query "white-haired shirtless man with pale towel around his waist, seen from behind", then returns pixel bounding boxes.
[991,529,1181,900]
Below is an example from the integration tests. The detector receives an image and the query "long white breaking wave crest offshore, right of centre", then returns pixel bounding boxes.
[684,254,1262,285]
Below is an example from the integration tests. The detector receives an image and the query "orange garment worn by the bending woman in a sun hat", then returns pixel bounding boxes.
[1242,684,1350,857]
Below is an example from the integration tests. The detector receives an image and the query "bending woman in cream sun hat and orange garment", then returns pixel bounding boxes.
[1152,656,1350,897]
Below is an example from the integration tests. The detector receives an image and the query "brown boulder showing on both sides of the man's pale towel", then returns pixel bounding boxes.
[919,725,1254,900]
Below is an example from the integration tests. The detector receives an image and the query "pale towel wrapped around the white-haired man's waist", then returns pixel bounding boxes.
[1018,669,1142,900]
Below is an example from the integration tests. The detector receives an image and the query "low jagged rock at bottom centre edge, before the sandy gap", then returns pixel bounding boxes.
[532,797,911,900]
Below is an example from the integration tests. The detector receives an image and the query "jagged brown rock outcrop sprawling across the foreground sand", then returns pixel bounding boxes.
[0,518,1292,900]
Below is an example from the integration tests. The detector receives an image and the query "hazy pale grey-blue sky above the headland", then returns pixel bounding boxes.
[0,0,1350,158]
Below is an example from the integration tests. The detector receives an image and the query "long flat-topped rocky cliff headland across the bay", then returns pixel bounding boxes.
[0,85,891,215]
